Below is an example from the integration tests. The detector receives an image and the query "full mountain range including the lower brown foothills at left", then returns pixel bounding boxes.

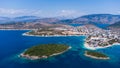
[0,14,120,29]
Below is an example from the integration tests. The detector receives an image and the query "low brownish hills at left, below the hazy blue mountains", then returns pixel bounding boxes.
[0,23,72,29]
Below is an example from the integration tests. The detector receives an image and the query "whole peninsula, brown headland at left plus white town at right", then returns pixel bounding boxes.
[23,24,120,50]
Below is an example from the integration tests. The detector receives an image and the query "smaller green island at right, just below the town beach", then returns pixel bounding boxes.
[85,51,110,60]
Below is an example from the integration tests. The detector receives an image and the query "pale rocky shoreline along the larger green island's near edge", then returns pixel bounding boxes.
[19,46,72,60]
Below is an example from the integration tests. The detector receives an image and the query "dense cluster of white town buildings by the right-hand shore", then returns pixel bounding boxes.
[80,26,120,47]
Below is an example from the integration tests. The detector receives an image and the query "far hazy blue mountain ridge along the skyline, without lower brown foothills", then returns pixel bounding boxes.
[0,14,120,24]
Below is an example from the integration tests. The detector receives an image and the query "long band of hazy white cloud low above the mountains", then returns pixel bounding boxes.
[0,8,84,17]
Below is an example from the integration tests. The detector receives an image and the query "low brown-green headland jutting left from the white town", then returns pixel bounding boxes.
[23,27,85,37]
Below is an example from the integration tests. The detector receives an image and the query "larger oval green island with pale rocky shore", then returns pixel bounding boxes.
[20,44,71,60]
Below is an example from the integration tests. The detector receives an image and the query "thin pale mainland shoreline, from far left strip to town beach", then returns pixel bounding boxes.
[0,29,120,50]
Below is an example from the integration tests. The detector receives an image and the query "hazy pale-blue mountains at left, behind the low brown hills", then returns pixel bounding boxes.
[0,16,60,24]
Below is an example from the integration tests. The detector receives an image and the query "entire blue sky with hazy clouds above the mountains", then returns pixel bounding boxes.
[0,0,120,17]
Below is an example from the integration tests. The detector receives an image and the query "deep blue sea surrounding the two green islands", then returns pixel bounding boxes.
[0,31,120,68]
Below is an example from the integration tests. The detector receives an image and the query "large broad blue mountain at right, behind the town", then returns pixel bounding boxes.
[72,14,120,24]
